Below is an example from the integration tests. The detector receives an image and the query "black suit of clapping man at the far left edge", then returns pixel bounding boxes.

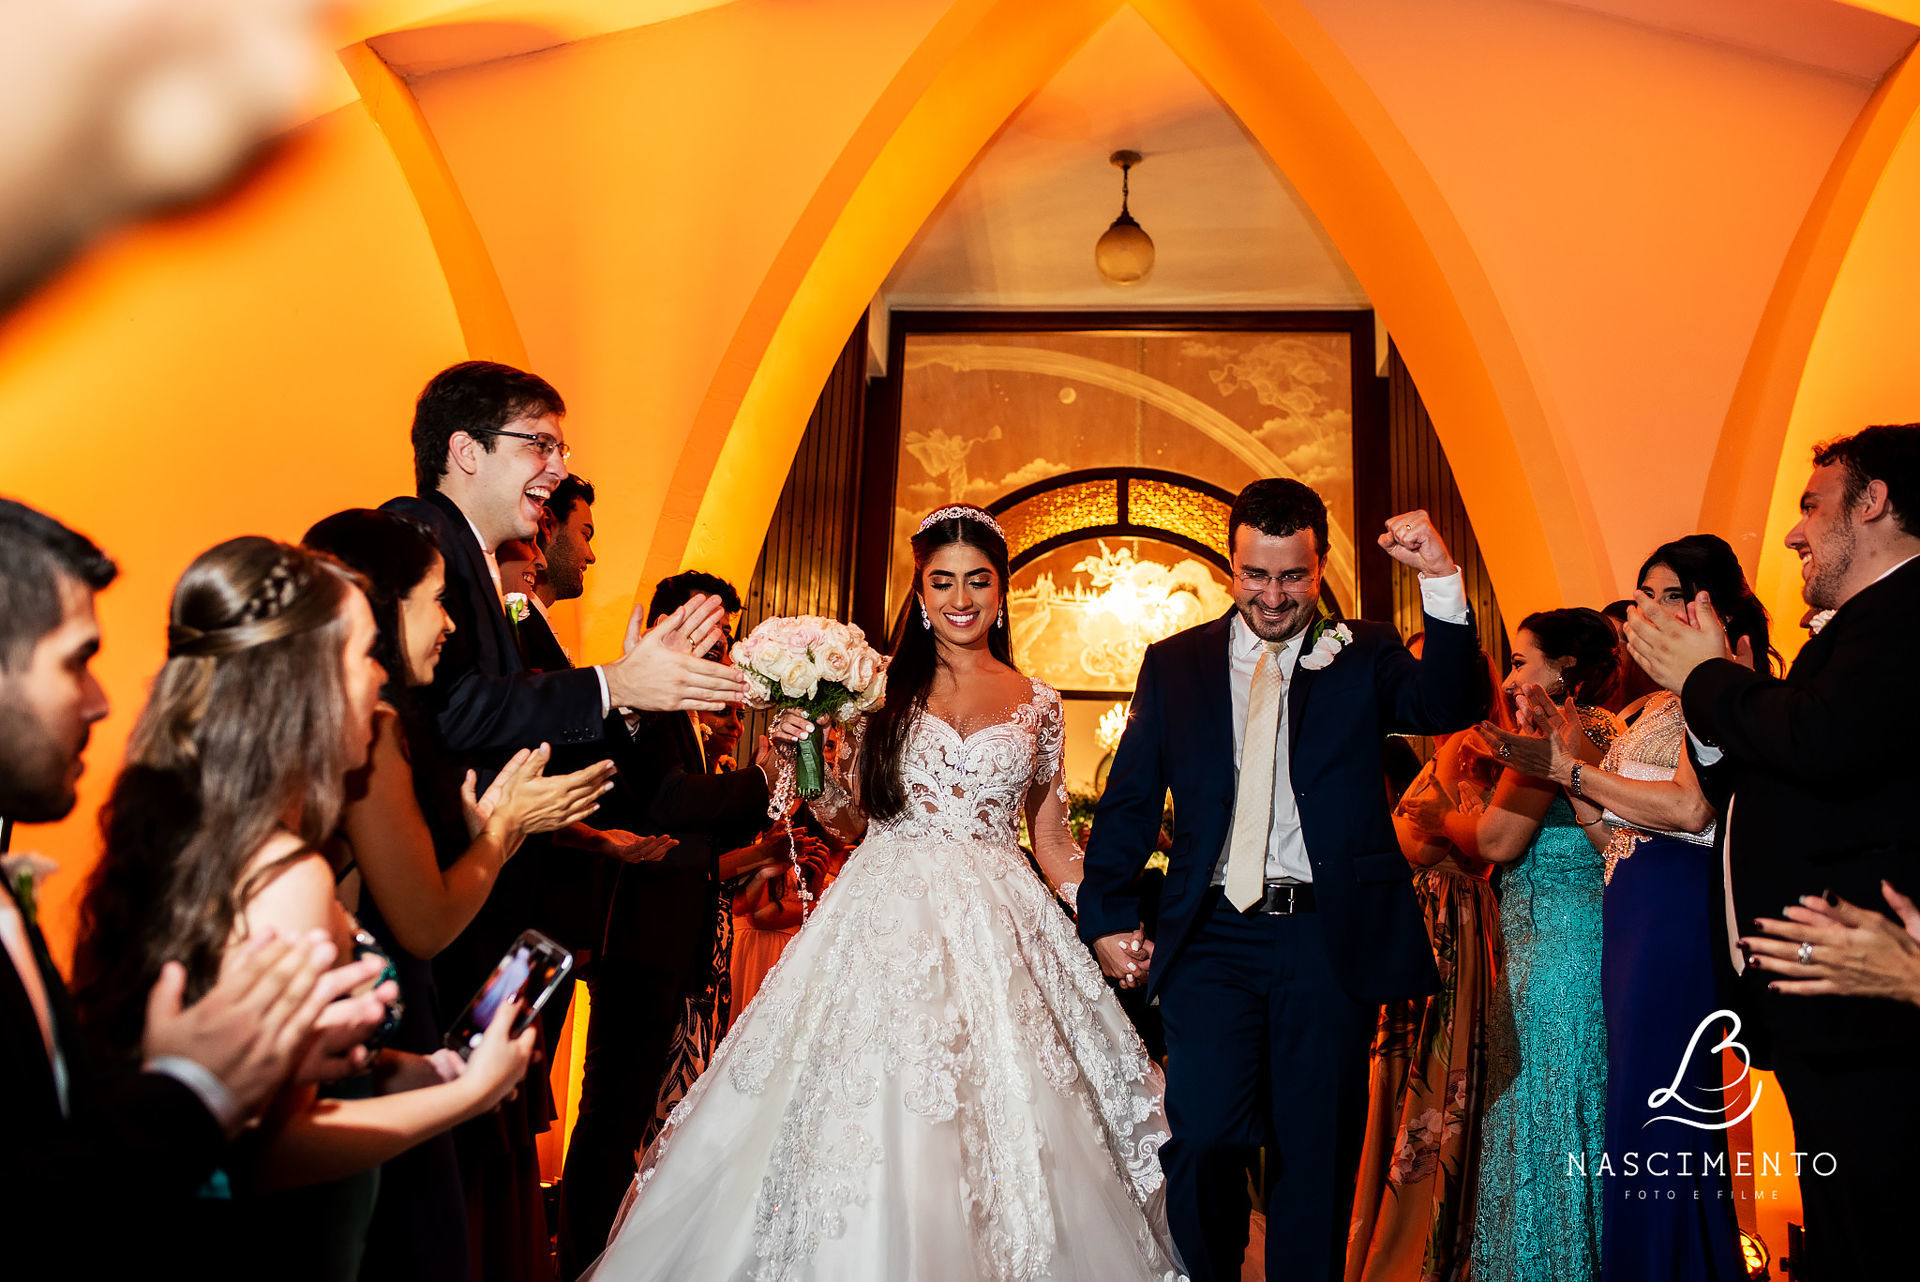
[0,887,227,1276]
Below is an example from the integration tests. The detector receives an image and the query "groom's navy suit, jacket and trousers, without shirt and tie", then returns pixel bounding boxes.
[1079,612,1486,1282]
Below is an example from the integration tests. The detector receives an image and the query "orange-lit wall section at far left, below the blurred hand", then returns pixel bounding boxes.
[0,104,465,956]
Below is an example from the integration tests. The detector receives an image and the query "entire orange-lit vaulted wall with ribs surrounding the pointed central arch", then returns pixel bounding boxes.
[0,0,1920,1205]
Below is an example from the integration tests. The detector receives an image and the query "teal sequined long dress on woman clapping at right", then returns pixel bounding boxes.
[1473,796,1607,1282]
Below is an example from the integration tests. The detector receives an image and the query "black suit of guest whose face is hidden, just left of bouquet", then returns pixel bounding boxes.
[561,712,768,1276]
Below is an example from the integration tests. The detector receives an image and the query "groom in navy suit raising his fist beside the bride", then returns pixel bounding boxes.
[1079,480,1486,1282]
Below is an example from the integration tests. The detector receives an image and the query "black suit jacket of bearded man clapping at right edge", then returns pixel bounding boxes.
[1680,560,1920,1050]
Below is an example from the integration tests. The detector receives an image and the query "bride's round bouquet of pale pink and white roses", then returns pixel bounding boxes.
[733,614,887,796]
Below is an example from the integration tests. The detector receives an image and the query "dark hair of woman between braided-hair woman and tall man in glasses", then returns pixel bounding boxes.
[300,507,467,866]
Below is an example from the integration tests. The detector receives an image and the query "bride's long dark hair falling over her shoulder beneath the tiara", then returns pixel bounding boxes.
[860,505,1014,819]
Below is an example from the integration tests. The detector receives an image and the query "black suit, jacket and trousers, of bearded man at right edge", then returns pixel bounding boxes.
[1680,560,1920,1282]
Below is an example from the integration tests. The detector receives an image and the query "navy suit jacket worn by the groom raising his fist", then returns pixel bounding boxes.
[1079,612,1486,1004]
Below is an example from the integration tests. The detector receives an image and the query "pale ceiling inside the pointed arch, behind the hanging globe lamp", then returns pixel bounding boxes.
[883,8,1369,307]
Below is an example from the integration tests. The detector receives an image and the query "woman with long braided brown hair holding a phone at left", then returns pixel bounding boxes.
[75,537,534,1280]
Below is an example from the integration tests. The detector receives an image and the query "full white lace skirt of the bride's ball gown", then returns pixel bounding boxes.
[589,831,1179,1282]
